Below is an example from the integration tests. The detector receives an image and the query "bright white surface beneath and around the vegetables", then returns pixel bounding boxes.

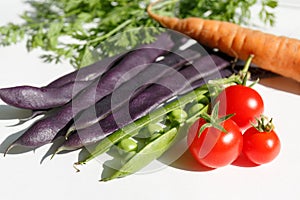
[0,0,300,200]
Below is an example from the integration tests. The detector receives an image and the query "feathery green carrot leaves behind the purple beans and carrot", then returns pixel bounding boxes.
[0,0,277,67]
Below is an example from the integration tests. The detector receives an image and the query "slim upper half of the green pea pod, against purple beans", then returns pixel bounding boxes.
[75,87,207,165]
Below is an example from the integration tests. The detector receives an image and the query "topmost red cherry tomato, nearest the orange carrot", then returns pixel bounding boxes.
[216,85,264,129]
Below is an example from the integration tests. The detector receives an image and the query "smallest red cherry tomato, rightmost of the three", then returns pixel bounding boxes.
[243,127,281,165]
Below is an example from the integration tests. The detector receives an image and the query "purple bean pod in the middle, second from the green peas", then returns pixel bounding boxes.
[69,49,201,132]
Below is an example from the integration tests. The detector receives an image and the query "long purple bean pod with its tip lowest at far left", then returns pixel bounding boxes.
[6,34,174,152]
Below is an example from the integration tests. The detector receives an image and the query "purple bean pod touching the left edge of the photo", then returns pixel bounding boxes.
[0,54,123,110]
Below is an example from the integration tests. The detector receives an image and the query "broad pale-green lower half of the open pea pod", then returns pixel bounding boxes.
[101,128,177,181]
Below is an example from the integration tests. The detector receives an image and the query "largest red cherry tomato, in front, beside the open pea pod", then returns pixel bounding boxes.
[187,118,243,168]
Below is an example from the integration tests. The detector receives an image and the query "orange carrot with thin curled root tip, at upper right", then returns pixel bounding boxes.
[147,2,300,82]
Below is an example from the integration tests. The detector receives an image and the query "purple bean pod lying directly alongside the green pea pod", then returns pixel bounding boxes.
[59,55,230,151]
